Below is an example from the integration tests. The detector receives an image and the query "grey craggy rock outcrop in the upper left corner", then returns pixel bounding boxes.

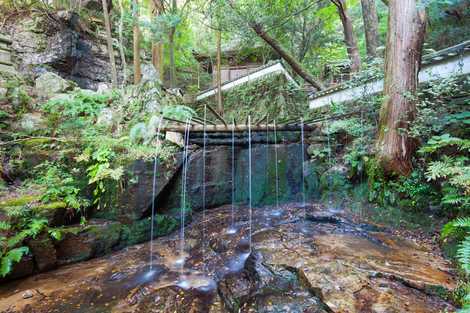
[4,11,119,90]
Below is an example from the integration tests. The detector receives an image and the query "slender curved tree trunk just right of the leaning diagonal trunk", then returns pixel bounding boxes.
[331,0,361,73]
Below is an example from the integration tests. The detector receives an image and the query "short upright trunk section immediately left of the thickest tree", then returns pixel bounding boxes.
[361,0,379,58]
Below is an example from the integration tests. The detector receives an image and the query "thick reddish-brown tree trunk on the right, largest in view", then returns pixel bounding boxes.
[377,0,426,175]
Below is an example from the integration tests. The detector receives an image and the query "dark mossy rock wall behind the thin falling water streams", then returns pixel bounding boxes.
[158,143,318,210]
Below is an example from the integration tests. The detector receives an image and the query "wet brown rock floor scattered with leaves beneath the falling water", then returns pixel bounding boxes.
[0,205,455,313]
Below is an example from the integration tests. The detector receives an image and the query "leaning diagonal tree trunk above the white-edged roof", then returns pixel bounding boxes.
[250,23,324,90]
